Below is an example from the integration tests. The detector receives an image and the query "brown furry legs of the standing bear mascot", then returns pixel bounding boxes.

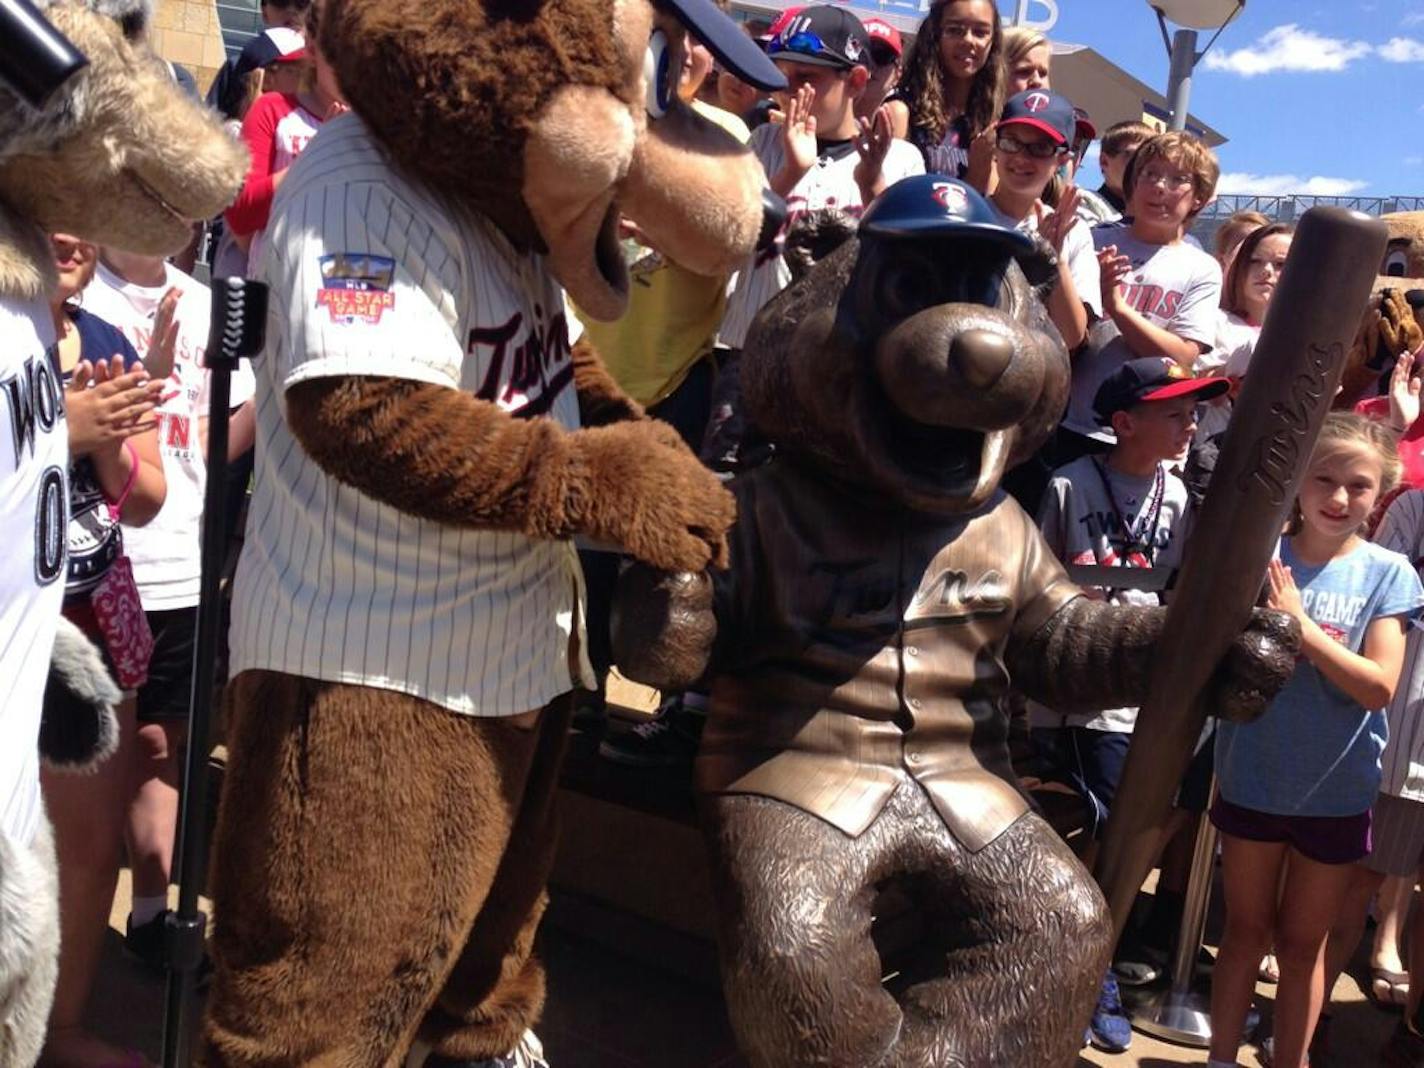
[204,671,571,1068]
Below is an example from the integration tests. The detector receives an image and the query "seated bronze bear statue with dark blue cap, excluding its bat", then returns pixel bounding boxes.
[614,175,1299,1068]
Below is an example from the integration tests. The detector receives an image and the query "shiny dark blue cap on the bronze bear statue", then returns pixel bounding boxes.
[860,174,1035,255]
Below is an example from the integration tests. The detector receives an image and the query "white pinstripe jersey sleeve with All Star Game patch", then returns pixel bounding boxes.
[265,182,474,389]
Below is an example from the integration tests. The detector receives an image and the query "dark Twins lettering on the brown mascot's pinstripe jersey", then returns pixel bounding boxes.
[466,303,574,417]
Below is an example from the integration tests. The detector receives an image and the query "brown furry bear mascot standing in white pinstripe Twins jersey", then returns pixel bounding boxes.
[201,0,785,1068]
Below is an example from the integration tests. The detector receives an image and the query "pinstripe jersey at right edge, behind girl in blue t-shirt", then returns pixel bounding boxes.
[1374,490,1424,800]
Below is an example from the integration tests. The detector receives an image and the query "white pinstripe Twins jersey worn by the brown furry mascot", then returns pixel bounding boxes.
[232,115,592,716]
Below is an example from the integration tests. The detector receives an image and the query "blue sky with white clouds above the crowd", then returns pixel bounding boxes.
[1030,0,1424,197]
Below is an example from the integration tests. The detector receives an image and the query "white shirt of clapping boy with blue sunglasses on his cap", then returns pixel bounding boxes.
[718,124,924,349]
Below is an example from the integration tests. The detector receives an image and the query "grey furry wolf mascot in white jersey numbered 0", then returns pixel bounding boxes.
[0,0,246,1068]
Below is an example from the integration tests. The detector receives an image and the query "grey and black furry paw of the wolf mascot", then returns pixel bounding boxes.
[40,617,124,773]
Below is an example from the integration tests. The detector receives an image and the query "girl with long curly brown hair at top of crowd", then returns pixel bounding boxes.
[887,0,1005,192]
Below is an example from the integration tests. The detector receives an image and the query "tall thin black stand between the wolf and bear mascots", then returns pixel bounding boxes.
[164,278,266,1068]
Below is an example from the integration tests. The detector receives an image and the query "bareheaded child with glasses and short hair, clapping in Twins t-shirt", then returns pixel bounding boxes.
[1057,132,1222,463]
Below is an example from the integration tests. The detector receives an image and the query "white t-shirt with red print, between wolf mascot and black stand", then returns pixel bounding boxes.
[84,263,253,612]
